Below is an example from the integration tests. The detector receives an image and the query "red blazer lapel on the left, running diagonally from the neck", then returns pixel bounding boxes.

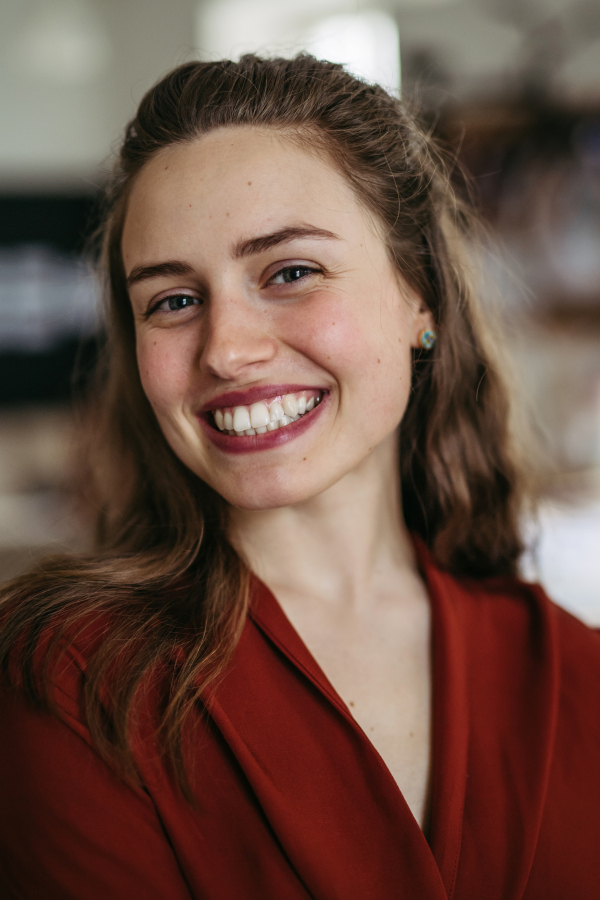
[210,583,446,900]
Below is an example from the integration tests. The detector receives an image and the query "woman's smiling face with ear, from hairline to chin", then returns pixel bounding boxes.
[122,128,431,509]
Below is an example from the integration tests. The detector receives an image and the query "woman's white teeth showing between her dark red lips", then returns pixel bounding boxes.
[212,390,323,437]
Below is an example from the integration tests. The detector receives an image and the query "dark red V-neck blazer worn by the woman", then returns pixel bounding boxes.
[0,536,600,900]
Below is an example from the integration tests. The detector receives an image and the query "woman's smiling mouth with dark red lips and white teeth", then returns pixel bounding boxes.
[199,388,327,452]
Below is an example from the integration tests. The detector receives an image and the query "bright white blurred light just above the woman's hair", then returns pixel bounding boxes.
[302,10,400,92]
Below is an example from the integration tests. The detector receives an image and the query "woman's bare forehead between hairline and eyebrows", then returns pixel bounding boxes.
[123,127,376,264]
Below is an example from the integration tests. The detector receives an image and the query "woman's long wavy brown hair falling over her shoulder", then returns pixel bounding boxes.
[0,54,522,789]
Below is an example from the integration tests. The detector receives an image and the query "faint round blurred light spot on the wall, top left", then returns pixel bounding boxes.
[13,0,111,85]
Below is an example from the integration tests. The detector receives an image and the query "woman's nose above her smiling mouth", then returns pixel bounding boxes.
[200,295,277,381]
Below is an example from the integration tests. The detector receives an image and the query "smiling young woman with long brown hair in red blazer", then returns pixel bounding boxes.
[0,56,600,900]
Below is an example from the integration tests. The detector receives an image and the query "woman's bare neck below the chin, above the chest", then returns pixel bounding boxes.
[230,434,415,605]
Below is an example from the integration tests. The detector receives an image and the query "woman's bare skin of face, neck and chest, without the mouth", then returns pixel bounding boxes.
[122,128,432,827]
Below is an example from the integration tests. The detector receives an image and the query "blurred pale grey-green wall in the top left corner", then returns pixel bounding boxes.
[0,0,196,192]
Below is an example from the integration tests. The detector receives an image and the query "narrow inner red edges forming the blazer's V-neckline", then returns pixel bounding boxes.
[249,538,469,900]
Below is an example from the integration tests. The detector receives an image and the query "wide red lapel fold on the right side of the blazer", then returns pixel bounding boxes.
[414,548,560,900]
